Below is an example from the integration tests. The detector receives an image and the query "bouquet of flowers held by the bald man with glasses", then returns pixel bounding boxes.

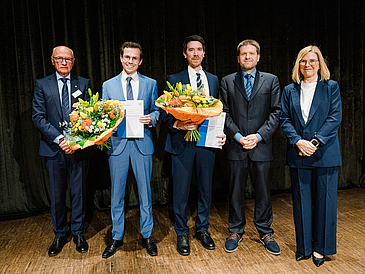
[60,89,124,150]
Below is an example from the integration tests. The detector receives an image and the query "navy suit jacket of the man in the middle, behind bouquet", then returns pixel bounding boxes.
[160,69,219,154]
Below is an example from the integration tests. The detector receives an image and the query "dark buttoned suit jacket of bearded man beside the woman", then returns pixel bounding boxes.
[220,70,281,161]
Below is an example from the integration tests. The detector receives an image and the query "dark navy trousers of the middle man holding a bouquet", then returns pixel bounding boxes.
[171,143,215,236]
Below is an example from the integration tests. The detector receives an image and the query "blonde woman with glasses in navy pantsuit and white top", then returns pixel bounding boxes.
[280,46,342,267]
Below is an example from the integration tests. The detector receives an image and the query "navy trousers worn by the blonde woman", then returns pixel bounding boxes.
[290,167,339,256]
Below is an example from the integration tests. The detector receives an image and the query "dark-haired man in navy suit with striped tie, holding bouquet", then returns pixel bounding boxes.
[161,35,226,256]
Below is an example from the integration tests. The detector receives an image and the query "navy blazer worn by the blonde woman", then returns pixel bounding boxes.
[280,80,342,168]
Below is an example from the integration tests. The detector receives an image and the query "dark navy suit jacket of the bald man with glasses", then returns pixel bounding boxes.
[32,73,90,157]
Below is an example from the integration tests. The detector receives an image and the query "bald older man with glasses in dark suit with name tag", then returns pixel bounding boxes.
[32,46,90,256]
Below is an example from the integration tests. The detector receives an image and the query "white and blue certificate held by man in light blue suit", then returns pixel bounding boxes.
[117,100,144,138]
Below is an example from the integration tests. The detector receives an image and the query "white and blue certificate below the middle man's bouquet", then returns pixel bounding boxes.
[196,112,226,148]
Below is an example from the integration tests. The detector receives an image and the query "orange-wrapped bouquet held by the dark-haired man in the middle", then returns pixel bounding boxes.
[155,82,223,141]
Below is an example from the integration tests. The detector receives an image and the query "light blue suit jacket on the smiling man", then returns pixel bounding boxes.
[102,73,160,155]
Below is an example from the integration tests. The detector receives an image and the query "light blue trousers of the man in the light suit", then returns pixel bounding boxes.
[109,141,153,240]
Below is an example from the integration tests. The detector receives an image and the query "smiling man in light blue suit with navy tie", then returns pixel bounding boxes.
[102,42,159,258]
